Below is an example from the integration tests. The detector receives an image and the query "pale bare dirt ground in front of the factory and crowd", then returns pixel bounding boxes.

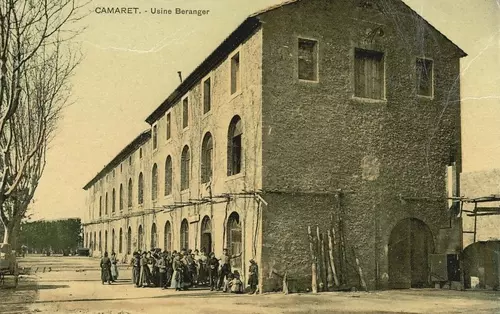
[0,257,500,314]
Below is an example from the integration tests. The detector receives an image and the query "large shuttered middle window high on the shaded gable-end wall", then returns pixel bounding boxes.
[354,49,385,99]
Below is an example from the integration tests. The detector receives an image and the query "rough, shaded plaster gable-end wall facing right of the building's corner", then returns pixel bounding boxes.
[262,0,461,288]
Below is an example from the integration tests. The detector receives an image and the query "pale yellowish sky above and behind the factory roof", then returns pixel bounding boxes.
[30,0,500,219]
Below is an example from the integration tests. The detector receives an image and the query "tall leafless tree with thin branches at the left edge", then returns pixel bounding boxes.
[0,0,82,244]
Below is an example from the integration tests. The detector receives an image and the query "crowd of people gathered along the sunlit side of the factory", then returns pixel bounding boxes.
[101,249,259,293]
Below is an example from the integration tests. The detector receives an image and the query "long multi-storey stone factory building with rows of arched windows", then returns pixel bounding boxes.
[84,0,465,290]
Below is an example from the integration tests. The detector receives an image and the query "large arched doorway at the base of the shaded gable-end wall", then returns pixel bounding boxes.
[389,218,434,289]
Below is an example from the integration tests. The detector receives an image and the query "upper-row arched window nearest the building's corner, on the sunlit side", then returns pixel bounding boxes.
[227,116,243,176]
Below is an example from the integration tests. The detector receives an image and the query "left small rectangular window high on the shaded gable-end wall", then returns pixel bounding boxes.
[297,38,318,81]
